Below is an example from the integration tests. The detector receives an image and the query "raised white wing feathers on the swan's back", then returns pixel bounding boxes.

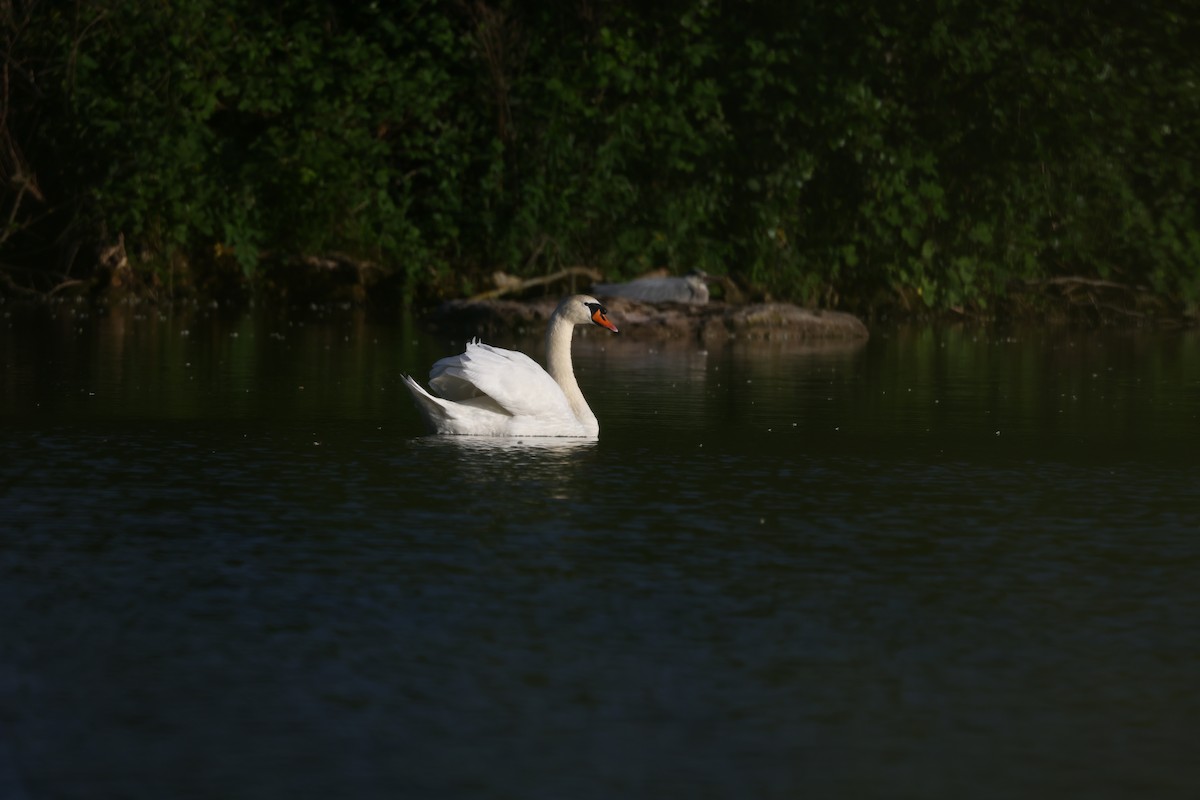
[430,342,574,419]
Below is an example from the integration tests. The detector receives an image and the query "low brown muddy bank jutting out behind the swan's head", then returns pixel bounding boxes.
[426,297,869,344]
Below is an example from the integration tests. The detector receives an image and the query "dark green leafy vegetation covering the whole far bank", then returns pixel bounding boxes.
[0,0,1200,319]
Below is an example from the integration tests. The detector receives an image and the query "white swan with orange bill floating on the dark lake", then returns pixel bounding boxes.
[404,295,617,439]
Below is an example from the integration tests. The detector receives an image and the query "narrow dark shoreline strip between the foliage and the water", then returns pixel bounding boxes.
[0,281,1200,331]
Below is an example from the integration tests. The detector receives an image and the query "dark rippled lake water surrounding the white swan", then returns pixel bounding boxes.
[0,305,1200,800]
